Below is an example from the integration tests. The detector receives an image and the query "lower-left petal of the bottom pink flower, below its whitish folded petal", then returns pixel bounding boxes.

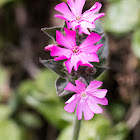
[64,95,80,113]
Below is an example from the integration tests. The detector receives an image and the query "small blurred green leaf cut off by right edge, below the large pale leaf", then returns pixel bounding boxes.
[132,29,140,59]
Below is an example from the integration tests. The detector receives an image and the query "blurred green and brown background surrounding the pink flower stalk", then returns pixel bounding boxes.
[0,0,140,140]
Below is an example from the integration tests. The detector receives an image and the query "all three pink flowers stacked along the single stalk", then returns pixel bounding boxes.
[45,0,108,120]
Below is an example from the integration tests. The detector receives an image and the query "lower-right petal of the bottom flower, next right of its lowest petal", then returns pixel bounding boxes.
[87,96,103,114]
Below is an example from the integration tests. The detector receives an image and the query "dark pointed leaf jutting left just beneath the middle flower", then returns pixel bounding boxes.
[39,59,67,78]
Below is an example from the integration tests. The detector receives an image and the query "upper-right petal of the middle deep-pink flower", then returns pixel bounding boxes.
[79,32,101,50]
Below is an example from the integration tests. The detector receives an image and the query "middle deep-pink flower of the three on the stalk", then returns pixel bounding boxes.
[51,28,103,73]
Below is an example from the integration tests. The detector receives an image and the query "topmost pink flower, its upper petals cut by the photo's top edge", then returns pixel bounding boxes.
[54,0,105,34]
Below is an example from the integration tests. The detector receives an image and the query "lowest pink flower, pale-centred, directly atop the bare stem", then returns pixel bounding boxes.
[64,80,108,120]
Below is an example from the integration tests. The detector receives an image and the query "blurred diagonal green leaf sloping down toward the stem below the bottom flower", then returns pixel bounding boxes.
[25,96,73,129]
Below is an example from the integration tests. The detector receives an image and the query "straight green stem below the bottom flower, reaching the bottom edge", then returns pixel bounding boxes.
[72,112,81,140]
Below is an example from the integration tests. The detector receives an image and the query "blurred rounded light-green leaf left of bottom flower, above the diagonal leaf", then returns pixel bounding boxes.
[17,69,58,101]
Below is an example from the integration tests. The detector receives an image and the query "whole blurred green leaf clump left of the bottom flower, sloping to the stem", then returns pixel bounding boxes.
[17,70,73,129]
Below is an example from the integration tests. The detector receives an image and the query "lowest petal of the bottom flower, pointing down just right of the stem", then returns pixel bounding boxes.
[83,100,94,120]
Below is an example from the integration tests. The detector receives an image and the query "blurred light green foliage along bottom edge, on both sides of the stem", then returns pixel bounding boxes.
[57,115,129,140]
